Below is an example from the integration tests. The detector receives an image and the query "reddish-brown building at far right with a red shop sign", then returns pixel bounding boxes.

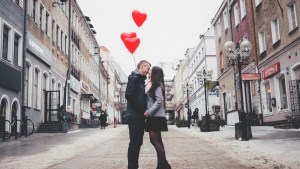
[252,0,300,125]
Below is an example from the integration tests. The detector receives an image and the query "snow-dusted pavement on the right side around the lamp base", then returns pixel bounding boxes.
[173,126,300,169]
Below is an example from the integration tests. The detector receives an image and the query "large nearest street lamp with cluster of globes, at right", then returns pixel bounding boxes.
[224,40,252,141]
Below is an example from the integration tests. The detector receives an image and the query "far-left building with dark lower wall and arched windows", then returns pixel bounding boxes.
[0,0,24,127]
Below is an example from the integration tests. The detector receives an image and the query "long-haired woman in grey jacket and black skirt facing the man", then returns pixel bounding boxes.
[144,66,171,169]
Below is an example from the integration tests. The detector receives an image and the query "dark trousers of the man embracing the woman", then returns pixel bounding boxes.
[127,118,145,169]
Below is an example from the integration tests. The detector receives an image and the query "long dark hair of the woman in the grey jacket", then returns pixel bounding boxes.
[149,66,166,108]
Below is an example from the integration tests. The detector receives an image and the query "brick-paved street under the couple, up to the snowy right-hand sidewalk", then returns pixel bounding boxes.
[0,126,253,169]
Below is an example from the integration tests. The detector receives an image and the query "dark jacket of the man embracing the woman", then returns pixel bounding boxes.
[125,71,146,118]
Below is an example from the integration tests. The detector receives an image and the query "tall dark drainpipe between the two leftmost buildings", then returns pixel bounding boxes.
[21,0,28,121]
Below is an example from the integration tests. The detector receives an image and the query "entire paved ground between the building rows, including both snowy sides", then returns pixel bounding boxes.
[0,125,300,169]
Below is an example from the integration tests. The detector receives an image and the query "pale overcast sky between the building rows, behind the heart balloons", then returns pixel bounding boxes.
[77,0,222,74]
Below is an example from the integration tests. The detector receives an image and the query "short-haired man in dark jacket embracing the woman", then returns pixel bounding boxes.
[125,60,151,169]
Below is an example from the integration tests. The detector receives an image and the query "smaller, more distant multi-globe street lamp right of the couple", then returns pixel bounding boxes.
[197,68,212,131]
